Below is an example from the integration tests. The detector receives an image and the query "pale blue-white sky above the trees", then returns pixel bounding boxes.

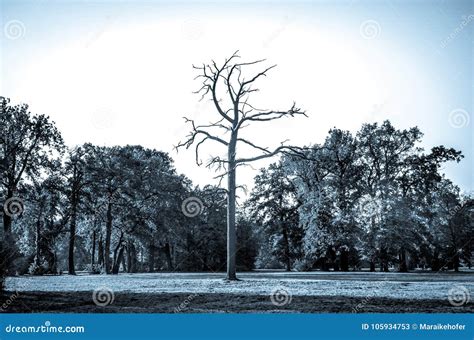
[0,0,474,191]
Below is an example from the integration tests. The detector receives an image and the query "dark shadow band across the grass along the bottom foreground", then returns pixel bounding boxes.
[0,292,474,313]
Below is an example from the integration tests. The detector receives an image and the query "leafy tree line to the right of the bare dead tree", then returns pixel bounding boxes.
[250,121,474,272]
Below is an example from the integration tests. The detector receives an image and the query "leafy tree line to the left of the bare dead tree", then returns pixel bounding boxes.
[0,98,257,286]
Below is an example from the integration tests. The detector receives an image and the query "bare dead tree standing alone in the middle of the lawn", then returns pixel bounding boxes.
[176,51,306,280]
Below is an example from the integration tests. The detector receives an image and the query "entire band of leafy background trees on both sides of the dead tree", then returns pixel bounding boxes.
[0,91,474,292]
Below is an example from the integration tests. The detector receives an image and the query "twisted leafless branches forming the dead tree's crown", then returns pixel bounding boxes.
[180,51,306,178]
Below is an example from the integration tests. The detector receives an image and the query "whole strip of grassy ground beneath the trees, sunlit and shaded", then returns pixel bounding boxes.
[0,271,474,313]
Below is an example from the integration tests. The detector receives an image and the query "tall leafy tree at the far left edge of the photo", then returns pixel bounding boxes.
[0,96,63,286]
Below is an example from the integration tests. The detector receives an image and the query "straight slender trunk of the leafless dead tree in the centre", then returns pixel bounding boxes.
[227,137,237,280]
